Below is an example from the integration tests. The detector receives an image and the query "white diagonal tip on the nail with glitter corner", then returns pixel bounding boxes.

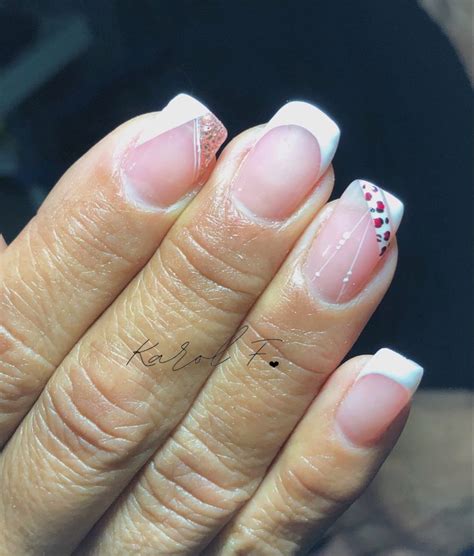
[138,93,210,145]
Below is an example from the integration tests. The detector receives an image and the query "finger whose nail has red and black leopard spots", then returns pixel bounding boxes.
[81,181,402,554]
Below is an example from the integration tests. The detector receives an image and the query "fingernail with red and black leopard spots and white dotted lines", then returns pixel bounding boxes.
[305,180,403,303]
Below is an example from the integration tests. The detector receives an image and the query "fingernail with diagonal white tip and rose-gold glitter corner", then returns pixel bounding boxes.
[122,94,227,207]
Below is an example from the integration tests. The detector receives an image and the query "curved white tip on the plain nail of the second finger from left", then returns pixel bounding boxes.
[265,101,341,175]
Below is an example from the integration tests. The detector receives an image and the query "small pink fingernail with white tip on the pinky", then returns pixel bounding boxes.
[336,348,423,446]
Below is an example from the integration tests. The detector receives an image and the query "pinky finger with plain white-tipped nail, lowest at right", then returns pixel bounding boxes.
[204,349,423,556]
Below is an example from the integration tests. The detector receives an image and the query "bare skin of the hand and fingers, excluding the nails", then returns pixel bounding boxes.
[0,101,414,554]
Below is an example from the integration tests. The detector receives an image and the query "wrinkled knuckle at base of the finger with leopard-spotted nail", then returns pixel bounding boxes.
[120,437,256,553]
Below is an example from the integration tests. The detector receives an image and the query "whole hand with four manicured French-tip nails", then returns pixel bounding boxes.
[0,95,422,555]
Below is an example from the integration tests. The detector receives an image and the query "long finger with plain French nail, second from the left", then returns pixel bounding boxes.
[0,103,338,553]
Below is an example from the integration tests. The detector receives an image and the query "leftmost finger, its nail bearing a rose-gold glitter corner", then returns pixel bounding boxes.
[0,95,225,447]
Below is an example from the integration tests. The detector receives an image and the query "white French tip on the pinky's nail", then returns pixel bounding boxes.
[358,348,423,394]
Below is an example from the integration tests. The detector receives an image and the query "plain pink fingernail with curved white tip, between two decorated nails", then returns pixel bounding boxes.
[232,102,340,220]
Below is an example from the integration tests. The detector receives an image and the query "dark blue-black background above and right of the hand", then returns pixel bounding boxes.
[0,0,473,387]
